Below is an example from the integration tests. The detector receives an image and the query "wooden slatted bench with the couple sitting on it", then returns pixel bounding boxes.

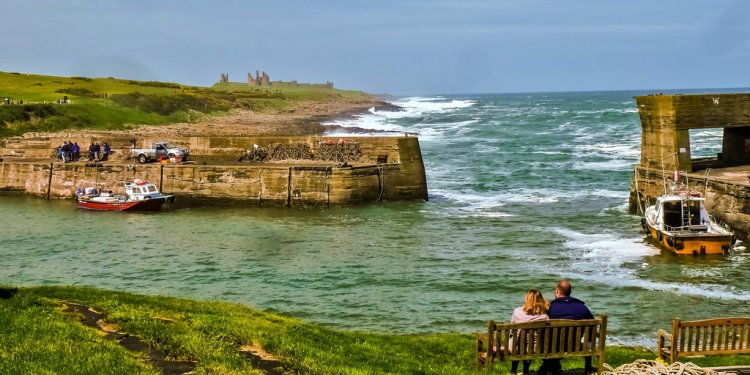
[477,315,607,372]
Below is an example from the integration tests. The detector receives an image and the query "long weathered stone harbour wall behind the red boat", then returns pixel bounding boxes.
[0,137,428,207]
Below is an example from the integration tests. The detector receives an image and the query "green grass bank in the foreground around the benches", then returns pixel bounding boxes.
[0,287,747,374]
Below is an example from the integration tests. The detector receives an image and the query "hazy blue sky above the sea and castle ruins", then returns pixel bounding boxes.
[0,0,750,95]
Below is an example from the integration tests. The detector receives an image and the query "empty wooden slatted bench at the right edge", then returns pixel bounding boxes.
[656,318,750,363]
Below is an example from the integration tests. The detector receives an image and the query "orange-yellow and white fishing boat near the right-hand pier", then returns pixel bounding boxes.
[641,191,734,255]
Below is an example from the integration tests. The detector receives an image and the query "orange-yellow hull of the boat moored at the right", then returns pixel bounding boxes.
[646,225,733,255]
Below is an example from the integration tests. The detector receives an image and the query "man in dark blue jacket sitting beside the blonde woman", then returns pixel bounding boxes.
[538,280,596,375]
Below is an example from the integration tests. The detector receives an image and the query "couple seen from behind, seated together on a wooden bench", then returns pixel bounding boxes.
[510,280,596,375]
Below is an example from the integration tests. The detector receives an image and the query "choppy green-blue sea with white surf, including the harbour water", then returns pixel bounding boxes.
[0,90,750,347]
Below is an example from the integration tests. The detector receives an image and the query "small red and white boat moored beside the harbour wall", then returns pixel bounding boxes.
[76,178,174,211]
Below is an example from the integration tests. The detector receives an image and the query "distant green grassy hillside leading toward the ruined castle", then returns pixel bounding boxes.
[0,72,368,137]
